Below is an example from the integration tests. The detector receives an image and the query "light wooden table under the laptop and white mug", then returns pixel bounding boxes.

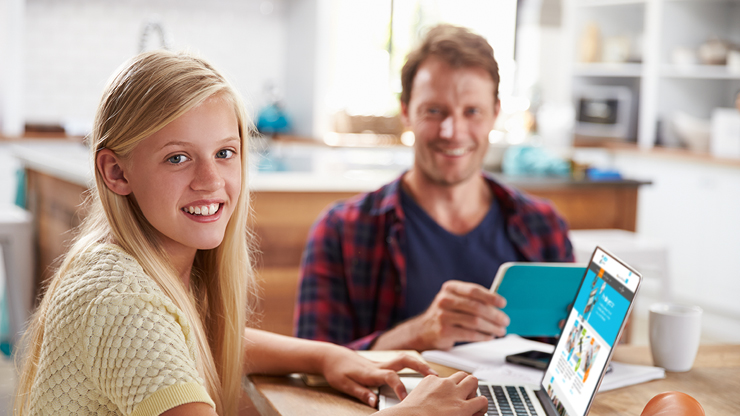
[244,345,740,416]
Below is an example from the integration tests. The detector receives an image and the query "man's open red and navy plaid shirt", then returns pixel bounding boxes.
[295,175,573,349]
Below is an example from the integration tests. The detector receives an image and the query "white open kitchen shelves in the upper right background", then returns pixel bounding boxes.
[563,0,740,149]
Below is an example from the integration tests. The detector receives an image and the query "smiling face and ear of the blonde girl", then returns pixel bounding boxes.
[98,96,242,262]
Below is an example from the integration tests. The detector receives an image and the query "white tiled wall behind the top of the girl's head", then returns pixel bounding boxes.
[20,0,286,132]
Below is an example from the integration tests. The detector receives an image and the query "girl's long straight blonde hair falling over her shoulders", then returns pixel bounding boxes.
[14,51,254,415]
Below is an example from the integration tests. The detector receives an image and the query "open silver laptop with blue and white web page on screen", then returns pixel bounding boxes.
[479,247,642,416]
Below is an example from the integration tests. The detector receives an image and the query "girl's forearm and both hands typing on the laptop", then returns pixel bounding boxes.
[244,328,488,416]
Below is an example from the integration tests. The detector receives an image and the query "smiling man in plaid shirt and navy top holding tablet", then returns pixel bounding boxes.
[296,25,573,351]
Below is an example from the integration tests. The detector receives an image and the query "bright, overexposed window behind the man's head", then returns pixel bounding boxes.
[325,0,516,145]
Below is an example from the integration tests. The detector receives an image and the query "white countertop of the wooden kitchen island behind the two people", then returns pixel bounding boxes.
[11,140,649,192]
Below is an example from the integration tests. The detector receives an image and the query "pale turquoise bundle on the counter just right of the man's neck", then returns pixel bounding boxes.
[501,146,570,176]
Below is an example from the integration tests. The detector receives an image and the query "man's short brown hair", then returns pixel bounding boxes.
[401,24,499,105]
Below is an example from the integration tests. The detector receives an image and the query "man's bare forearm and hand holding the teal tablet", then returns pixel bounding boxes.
[372,280,509,351]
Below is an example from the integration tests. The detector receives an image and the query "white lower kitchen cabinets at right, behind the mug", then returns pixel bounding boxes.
[610,149,740,343]
